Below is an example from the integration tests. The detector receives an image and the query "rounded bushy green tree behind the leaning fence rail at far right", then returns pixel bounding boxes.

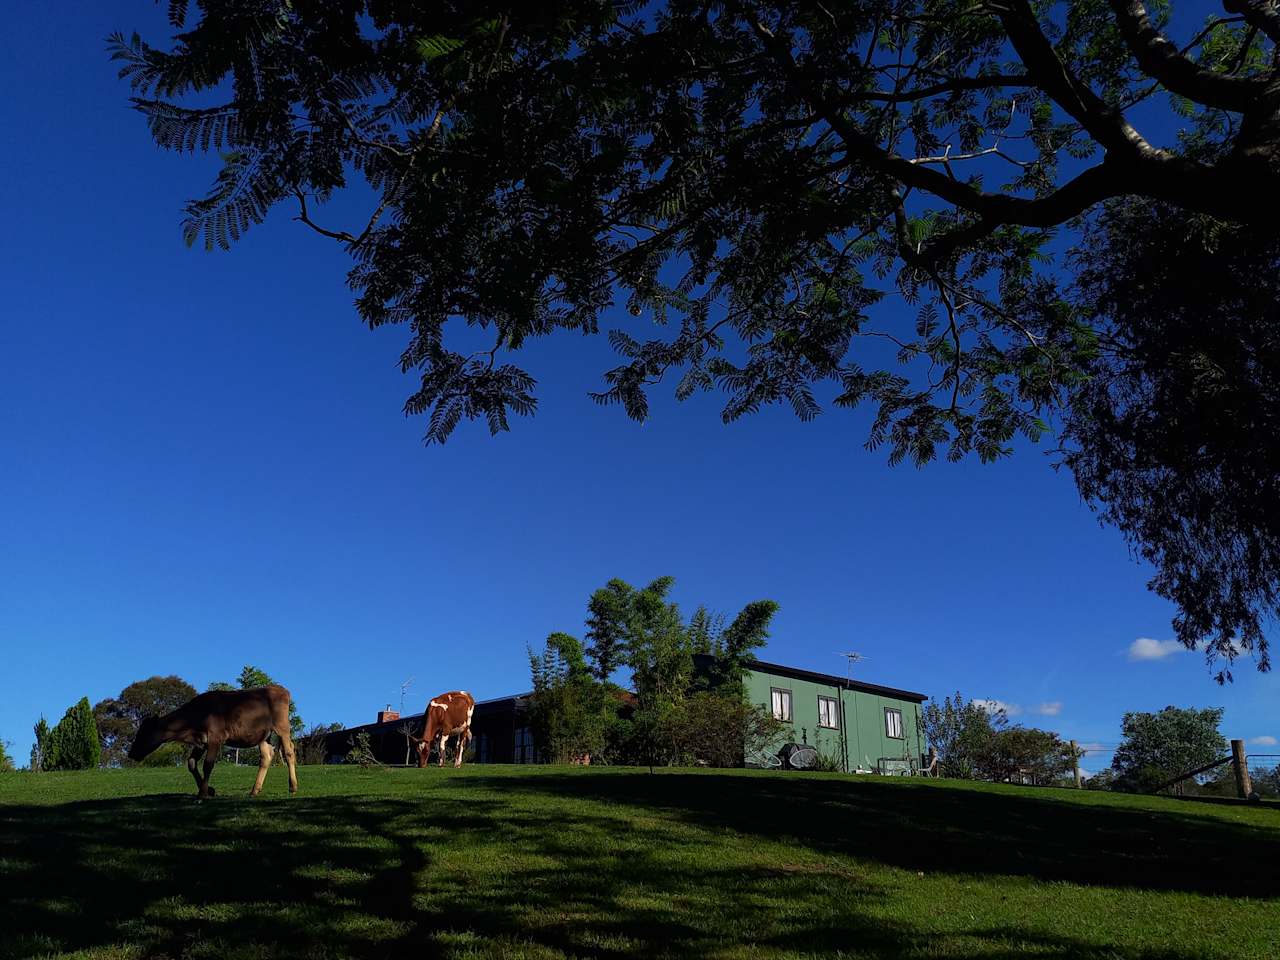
[1111,707,1226,790]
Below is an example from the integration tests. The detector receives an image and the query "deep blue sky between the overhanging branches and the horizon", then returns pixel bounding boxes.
[0,0,1280,768]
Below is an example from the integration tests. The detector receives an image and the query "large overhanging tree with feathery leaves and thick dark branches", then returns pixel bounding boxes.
[111,0,1280,668]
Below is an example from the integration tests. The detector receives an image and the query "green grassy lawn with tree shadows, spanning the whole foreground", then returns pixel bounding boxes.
[0,765,1280,960]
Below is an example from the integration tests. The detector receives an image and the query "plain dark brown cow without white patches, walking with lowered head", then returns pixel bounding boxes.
[129,685,298,800]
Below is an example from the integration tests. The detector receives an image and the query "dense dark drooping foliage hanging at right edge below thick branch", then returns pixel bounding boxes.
[1066,201,1280,680]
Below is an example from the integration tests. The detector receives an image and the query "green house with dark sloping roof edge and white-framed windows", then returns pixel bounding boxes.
[746,660,927,773]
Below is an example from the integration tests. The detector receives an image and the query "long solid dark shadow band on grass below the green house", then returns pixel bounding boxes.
[473,773,1280,900]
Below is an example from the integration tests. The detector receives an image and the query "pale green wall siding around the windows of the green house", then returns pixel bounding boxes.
[746,669,922,771]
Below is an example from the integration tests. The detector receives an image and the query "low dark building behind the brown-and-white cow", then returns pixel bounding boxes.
[325,694,535,764]
